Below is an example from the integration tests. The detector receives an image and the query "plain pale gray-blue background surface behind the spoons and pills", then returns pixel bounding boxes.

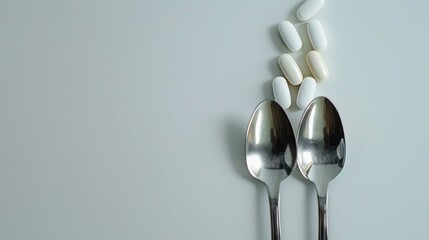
[0,0,429,240]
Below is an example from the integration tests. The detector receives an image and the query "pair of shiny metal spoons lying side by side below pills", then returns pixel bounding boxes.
[246,97,346,240]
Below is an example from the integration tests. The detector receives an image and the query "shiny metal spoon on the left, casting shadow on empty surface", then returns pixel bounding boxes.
[246,100,296,240]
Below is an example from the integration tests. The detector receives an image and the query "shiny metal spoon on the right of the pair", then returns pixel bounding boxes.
[297,97,346,240]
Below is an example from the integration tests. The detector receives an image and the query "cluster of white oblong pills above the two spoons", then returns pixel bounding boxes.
[272,0,329,109]
